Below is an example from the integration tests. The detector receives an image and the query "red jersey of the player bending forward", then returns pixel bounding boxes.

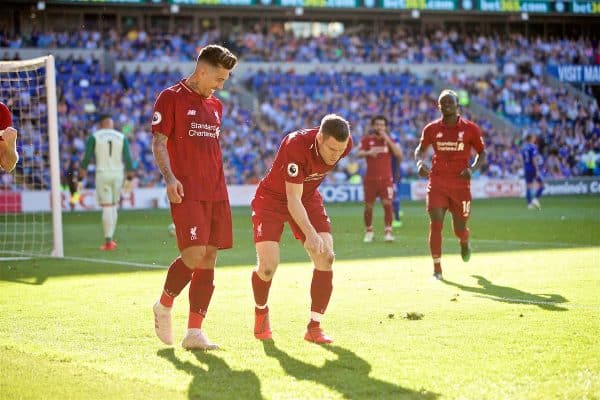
[256,127,352,205]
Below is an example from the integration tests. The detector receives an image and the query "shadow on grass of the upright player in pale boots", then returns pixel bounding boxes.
[157,348,263,400]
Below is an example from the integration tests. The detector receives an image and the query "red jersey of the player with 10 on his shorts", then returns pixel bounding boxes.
[421,117,485,186]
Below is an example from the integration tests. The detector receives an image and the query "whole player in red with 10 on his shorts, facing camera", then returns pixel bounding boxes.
[415,90,486,279]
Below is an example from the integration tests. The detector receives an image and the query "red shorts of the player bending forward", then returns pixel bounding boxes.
[252,192,331,243]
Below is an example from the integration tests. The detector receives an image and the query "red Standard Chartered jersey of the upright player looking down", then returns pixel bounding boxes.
[152,80,228,201]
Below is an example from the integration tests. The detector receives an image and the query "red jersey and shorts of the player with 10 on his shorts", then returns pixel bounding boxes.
[420,117,485,218]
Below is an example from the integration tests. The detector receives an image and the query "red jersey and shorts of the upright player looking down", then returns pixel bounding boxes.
[152,80,233,250]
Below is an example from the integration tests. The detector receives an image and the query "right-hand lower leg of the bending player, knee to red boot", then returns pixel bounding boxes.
[304,232,335,343]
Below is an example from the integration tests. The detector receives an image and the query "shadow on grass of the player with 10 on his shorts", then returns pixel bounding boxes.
[442,275,568,311]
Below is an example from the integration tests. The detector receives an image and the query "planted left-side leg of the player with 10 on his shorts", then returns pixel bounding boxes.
[427,188,449,279]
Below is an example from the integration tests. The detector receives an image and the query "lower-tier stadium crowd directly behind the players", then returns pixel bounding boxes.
[0,40,600,187]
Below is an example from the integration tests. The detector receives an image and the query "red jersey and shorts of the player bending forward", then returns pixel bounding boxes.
[252,127,352,243]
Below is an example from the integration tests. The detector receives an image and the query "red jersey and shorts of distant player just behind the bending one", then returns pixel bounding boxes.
[360,133,394,203]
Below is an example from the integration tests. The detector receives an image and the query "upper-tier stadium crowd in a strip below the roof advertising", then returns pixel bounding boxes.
[0,23,600,65]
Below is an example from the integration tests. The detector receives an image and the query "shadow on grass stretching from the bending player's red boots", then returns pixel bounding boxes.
[262,340,438,400]
